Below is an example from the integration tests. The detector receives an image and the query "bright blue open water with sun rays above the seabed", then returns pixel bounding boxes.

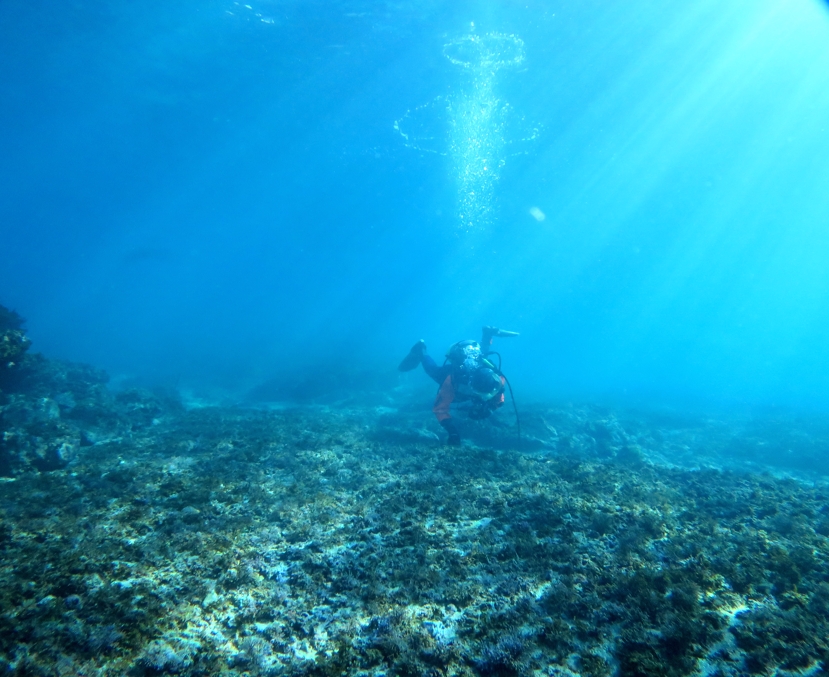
[0,0,829,408]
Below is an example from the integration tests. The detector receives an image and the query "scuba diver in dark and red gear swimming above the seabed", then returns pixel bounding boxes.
[398,327,518,446]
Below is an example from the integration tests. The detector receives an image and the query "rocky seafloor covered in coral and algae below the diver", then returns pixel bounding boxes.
[0,314,829,677]
